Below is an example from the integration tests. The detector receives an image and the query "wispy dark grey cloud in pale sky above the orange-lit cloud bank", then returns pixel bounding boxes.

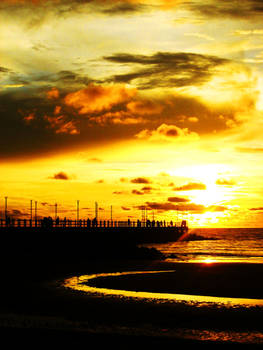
[104,52,231,89]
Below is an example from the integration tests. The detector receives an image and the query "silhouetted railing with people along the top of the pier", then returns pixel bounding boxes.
[0,217,187,230]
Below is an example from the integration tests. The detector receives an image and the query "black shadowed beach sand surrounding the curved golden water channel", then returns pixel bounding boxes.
[0,249,263,348]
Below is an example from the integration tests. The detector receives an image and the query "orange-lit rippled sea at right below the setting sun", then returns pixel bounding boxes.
[145,228,263,263]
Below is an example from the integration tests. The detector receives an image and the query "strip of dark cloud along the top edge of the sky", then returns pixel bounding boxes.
[0,0,263,27]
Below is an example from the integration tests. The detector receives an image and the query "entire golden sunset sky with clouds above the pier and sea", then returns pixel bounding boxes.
[0,0,263,227]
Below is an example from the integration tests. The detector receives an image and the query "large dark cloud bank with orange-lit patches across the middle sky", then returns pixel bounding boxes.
[0,78,248,158]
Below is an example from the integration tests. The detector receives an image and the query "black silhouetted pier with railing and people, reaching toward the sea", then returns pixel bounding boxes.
[0,217,188,254]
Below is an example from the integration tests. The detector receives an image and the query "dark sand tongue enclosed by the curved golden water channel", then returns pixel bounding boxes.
[83,263,263,299]
